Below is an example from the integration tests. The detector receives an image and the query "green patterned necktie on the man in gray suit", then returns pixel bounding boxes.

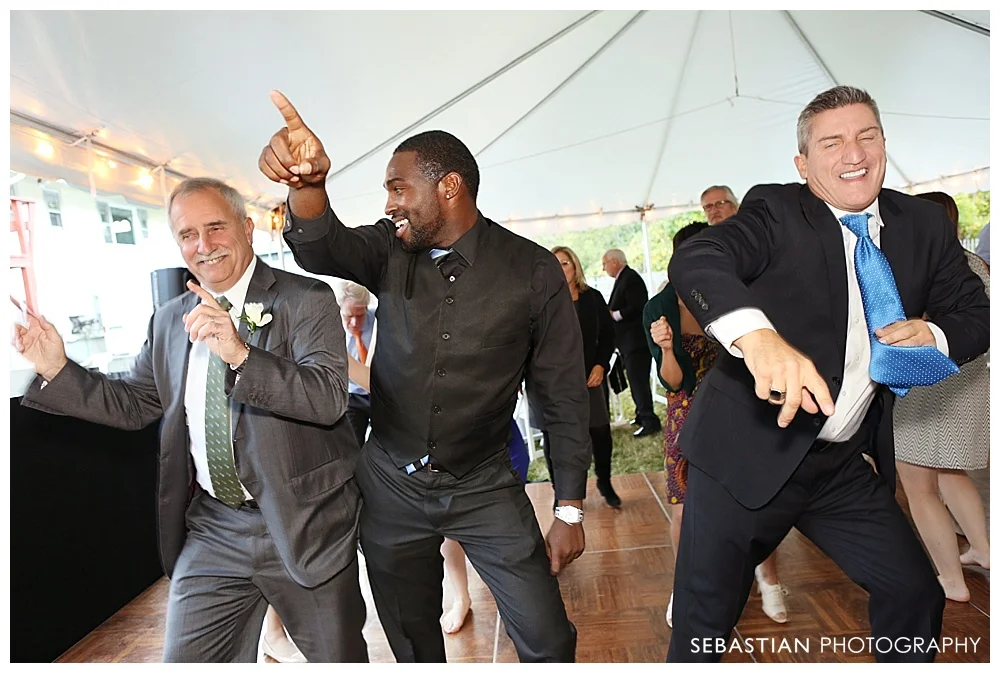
[205,296,246,508]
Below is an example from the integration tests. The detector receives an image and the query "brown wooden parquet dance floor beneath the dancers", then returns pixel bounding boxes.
[59,472,990,663]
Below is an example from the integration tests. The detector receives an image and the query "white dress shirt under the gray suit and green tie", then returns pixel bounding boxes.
[184,257,257,500]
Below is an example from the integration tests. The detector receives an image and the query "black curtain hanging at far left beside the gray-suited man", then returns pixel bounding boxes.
[10,398,163,663]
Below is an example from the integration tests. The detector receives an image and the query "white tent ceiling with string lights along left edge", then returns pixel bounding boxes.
[10,11,990,233]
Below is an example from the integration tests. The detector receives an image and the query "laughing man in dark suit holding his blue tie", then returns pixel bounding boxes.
[668,86,989,661]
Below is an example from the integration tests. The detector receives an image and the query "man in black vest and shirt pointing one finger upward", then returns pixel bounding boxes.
[259,92,591,662]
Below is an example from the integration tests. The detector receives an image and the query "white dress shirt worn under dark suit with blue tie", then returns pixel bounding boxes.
[706,199,948,442]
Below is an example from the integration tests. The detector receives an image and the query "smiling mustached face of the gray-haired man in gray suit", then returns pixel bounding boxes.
[170,189,253,294]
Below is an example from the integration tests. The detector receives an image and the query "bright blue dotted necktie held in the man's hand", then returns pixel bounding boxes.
[840,213,958,397]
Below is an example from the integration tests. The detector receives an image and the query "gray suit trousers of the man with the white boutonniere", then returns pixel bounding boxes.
[163,489,368,662]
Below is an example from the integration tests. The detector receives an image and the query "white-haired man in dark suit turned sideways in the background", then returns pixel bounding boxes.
[601,248,661,437]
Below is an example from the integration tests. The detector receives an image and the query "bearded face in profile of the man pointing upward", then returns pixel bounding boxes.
[385,152,445,252]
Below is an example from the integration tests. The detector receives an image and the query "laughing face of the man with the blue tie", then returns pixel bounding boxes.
[795,103,886,213]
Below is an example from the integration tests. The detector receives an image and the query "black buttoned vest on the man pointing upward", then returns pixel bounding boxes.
[371,218,538,477]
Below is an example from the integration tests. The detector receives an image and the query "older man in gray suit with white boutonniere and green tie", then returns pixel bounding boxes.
[14,178,368,662]
